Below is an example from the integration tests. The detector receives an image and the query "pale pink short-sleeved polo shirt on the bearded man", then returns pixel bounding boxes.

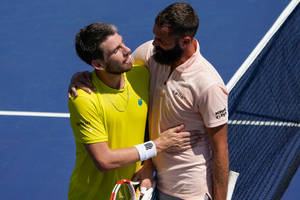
[133,41,228,199]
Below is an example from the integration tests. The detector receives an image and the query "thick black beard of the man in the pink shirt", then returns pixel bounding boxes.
[153,42,183,65]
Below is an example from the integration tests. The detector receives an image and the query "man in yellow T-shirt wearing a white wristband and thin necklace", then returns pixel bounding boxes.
[69,23,195,200]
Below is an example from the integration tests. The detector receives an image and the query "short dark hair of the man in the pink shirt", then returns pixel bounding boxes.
[155,2,199,37]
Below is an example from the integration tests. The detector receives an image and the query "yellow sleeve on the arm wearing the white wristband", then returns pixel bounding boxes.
[68,90,108,144]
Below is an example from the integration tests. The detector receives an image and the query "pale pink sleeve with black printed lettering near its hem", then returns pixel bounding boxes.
[198,84,228,128]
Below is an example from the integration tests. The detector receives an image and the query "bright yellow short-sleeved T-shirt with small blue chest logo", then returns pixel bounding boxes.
[69,66,149,200]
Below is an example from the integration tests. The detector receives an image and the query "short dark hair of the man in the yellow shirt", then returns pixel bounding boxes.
[75,22,118,65]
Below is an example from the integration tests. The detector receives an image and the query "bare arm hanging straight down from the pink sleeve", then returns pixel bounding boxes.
[207,124,229,200]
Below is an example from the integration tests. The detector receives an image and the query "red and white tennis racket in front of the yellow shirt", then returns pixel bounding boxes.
[110,179,155,200]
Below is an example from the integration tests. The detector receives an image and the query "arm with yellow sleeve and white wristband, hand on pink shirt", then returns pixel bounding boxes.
[68,90,198,171]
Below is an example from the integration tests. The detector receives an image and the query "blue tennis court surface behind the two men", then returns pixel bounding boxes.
[0,0,300,200]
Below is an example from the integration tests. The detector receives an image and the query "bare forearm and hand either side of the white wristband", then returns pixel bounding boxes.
[85,125,197,172]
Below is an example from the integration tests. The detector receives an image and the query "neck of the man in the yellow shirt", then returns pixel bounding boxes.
[96,71,125,90]
